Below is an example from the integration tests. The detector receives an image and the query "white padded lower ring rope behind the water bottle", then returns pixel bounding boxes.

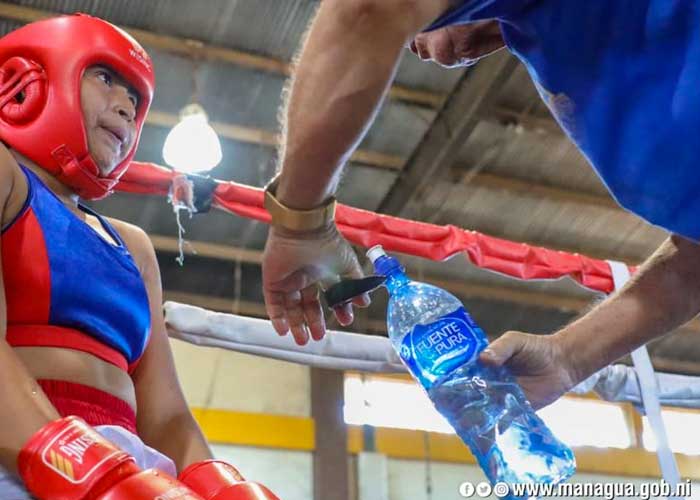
[164,302,700,412]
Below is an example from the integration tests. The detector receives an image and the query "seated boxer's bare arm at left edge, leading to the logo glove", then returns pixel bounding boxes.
[0,146,59,474]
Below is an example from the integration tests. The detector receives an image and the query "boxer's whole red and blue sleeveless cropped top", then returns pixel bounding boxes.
[2,166,151,371]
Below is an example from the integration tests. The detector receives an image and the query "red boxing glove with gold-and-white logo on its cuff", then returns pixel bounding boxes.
[18,417,202,500]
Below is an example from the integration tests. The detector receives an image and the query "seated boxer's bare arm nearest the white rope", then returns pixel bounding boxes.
[127,226,213,470]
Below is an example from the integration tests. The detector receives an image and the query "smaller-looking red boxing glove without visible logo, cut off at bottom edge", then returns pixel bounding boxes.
[178,460,280,500]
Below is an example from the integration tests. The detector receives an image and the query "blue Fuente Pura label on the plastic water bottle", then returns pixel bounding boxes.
[399,307,488,389]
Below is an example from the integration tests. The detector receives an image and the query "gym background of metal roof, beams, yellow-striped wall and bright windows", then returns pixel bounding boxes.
[0,0,700,500]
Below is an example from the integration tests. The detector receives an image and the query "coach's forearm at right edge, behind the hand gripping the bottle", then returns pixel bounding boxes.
[557,237,700,380]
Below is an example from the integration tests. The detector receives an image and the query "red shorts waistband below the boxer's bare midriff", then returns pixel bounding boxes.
[37,380,137,434]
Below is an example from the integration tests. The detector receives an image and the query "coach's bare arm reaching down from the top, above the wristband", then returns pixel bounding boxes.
[277,0,451,209]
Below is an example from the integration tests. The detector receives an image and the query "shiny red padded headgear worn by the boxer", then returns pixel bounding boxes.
[0,14,155,199]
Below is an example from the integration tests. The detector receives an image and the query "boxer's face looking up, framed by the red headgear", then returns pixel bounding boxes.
[80,66,139,177]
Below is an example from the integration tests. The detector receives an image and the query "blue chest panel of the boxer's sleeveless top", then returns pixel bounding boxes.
[17,169,151,363]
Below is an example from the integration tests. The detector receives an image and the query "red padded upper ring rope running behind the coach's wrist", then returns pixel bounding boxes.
[117,162,634,294]
